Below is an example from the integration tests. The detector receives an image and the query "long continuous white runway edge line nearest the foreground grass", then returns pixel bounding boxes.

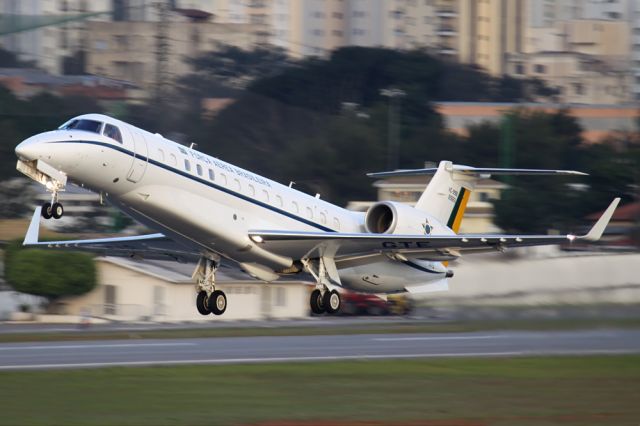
[0,349,638,371]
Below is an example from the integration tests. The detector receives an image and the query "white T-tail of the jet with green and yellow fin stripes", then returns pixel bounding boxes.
[369,161,586,233]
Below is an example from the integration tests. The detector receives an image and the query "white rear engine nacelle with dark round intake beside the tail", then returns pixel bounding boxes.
[364,201,439,235]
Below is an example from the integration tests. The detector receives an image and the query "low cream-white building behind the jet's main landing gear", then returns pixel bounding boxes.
[56,257,312,322]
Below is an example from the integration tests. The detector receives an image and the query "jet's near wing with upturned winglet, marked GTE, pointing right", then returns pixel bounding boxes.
[249,198,620,264]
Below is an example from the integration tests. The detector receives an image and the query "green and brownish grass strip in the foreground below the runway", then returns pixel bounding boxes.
[0,355,640,426]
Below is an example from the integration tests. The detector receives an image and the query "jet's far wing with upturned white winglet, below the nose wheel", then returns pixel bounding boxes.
[23,207,199,262]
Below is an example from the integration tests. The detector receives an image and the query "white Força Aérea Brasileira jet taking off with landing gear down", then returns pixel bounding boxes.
[15,114,619,315]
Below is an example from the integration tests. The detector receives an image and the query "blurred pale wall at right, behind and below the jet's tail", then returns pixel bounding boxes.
[428,247,640,305]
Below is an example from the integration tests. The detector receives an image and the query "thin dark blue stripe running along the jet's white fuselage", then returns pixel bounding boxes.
[49,140,336,232]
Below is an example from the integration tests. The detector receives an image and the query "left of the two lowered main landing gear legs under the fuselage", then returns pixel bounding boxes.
[193,256,227,315]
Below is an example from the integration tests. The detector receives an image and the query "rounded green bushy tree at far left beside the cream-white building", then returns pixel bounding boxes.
[5,243,96,302]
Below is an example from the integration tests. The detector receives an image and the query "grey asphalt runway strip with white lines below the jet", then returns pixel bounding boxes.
[0,330,640,371]
